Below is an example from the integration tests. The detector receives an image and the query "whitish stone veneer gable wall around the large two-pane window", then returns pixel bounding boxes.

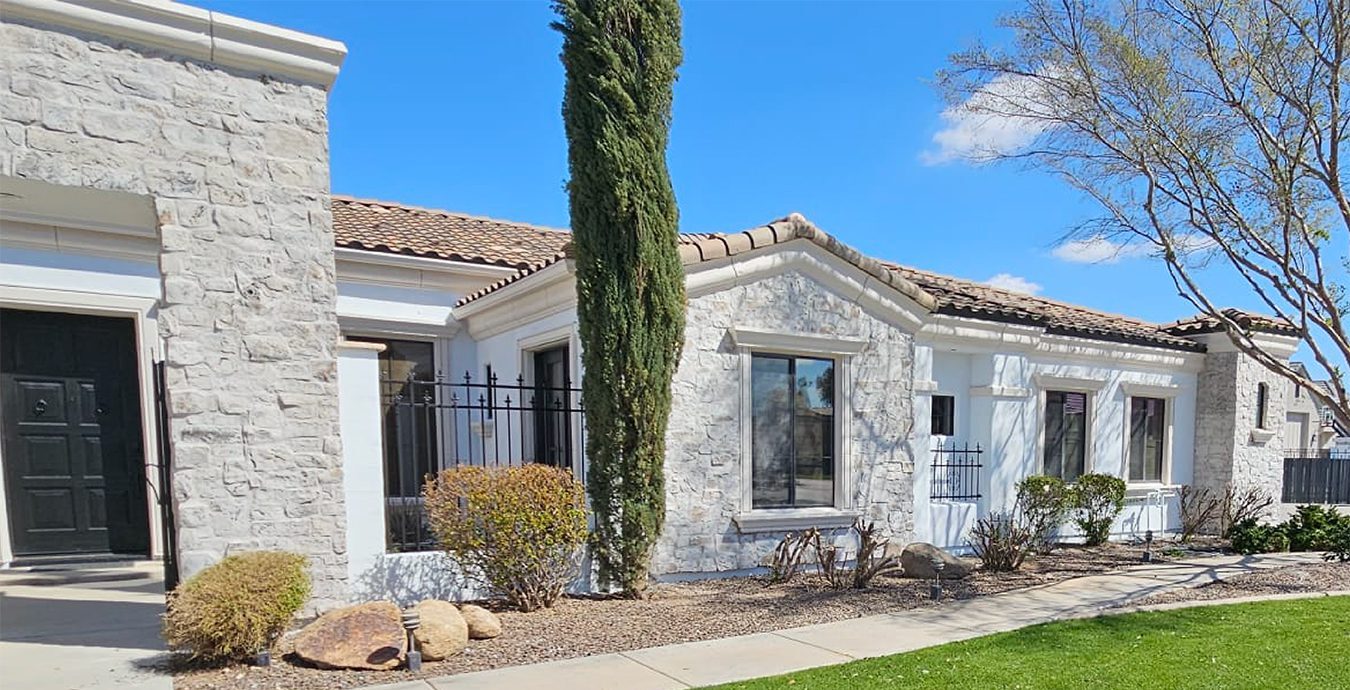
[652,273,914,574]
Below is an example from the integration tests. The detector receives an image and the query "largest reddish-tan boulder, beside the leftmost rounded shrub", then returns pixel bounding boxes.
[296,601,408,671]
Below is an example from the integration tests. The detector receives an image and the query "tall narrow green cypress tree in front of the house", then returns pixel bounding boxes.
[554,0,684,597]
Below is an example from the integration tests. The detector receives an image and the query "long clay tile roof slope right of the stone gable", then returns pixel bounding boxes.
[887,263,1204,351]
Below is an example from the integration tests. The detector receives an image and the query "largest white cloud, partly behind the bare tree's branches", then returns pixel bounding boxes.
[919,74,1050,165]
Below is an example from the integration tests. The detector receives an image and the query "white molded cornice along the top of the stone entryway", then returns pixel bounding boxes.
[0,0,347,89]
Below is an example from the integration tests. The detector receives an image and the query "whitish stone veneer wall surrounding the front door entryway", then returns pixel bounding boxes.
[0,22,346,608]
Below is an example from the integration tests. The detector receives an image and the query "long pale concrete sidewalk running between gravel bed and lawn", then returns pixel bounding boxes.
[373,554,1320,690]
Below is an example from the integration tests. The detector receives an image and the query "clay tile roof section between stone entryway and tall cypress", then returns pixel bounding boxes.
[332,196,572,269]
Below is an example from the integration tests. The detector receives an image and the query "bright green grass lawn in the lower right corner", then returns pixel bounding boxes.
[718,597,1350,690]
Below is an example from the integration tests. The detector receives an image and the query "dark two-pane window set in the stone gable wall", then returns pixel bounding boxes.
[751,354,836,508]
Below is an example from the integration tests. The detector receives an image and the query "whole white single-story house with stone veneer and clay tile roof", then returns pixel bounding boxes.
[0,0,1297,608]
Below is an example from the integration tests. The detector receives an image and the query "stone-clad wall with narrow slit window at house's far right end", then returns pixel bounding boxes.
[1195,351,1289,500]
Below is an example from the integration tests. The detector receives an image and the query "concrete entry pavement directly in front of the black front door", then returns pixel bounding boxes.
[0,563,173,690]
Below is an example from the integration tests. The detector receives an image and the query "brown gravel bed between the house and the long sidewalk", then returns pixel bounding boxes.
[173,544,1166,690]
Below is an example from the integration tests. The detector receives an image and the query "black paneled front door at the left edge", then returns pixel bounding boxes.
[0,309,150,556]
